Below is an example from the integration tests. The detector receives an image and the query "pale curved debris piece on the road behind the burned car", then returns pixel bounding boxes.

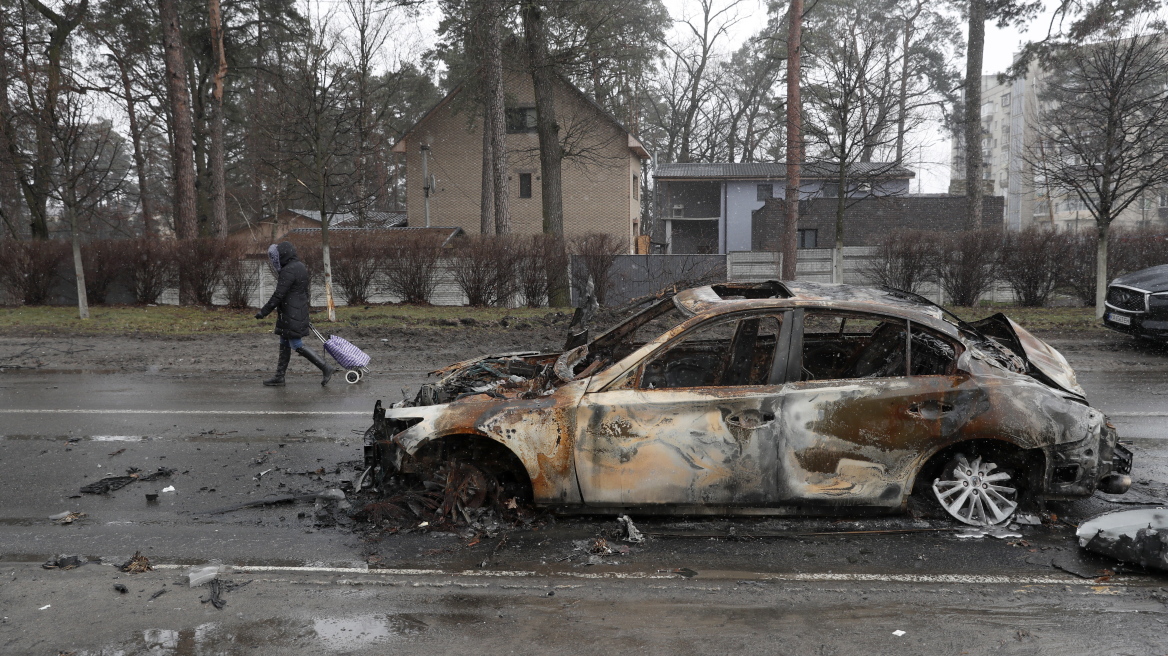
[1076,508,1168,570]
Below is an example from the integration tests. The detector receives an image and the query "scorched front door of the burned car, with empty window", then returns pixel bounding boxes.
[575,310,791,507]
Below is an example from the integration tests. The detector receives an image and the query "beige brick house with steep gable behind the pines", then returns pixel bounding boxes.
[394,71,648,252]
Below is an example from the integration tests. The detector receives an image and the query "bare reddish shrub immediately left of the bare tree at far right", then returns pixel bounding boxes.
[997,226,1071,307]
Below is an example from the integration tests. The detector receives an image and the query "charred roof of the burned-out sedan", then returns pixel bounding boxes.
[674,280,958,335]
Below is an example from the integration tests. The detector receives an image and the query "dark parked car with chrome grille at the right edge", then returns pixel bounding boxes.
[1103,264,1168,339]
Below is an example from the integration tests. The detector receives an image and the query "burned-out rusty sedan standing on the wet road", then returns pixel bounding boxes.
[366,281,1132,524]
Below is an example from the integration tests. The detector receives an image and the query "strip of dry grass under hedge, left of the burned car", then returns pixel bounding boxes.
[0,306,565,336]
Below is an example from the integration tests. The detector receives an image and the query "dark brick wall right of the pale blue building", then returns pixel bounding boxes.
[751,195,1006,251]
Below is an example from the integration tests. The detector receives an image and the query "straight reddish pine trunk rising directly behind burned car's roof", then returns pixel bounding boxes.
[779,0,802,280]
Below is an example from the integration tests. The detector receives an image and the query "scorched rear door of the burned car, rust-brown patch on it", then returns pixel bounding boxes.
[777,308,986,507]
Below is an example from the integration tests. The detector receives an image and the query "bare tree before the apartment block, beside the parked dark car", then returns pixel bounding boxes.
[1027,23,1168,316]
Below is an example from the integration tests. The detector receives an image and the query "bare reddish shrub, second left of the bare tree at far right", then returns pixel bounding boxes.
[933,228,1002,307]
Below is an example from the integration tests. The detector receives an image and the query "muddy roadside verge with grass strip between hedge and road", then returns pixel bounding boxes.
[0,306,1168,375]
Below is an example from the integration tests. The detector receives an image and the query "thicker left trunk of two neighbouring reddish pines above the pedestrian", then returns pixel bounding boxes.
[159,0,195,240]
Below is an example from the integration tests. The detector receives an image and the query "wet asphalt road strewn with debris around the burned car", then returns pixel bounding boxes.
[0,345,1168,655]
